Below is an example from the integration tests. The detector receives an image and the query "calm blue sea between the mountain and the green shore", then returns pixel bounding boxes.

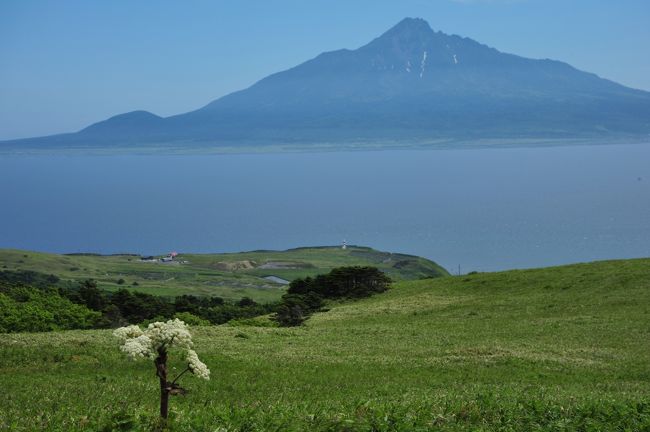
[0,144,650,272]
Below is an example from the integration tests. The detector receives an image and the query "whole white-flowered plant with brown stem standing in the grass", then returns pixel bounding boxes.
[113,319,210,419]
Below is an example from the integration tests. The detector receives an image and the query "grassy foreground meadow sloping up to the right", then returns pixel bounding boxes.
[0,259,650,431]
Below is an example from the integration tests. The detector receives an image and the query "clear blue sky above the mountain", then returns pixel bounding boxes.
[0,0,650,140]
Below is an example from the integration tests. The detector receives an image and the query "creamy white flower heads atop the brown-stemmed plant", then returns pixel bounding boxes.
[113,319,210,380]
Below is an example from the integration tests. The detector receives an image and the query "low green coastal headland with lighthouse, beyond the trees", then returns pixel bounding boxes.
[0,246,447,302]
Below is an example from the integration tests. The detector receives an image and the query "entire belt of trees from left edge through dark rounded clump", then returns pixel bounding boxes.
[0,266,391,333]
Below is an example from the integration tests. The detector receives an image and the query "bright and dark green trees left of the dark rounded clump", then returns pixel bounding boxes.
[0,271,276,333]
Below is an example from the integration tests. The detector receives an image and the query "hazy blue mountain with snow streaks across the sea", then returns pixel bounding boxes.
[5,18,650,150]
